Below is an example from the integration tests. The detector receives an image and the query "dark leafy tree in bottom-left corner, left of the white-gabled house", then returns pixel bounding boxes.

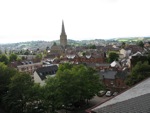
[3,73,33,113]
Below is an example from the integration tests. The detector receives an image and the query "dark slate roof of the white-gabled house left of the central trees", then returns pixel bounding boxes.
[36,65,58,80]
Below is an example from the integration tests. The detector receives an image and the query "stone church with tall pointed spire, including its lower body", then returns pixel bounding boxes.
[50,21,67,56]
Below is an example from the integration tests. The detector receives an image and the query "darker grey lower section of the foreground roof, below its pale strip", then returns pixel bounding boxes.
[96,93,150,113]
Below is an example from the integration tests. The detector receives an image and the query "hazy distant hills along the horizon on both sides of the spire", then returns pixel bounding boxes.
[0,37,150,51]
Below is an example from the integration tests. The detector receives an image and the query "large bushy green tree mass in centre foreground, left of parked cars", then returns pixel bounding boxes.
[56,64,102,107]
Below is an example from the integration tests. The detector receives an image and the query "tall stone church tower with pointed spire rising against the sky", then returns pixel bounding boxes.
[60,21,67,48]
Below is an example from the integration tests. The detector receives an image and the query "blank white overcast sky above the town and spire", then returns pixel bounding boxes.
[0,0,150,43]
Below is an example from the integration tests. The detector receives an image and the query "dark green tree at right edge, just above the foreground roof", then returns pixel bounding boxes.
[125,61,150,86]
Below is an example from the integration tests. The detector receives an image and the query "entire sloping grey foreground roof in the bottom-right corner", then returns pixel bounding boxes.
[92,78,150,113]
